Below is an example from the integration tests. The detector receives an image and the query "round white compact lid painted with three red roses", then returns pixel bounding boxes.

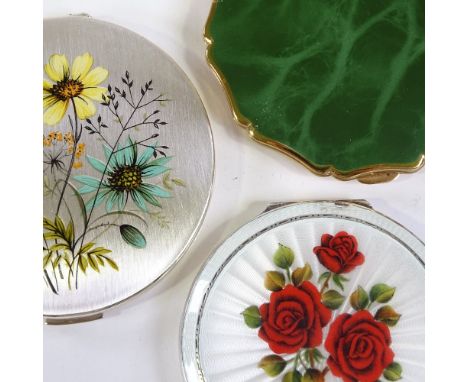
[182,202,424,382]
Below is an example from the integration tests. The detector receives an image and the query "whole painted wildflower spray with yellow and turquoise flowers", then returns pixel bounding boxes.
[42,64,186,295]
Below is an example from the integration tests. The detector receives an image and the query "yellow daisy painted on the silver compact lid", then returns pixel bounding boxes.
[43,53,109,125]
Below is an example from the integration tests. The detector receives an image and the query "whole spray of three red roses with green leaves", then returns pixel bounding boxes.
[242,237,403,382]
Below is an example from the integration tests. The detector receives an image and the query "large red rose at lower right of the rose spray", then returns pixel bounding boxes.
[325,310,394,382]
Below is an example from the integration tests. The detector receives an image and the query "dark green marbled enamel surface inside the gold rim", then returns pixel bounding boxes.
[208,0,424,172]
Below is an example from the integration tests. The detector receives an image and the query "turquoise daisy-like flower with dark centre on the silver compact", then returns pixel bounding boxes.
[75,138,171,212]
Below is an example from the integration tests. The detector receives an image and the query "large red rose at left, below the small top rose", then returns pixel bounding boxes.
[258,281,331,354]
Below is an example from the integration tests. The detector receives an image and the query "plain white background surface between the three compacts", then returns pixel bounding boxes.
[44,0,424,382]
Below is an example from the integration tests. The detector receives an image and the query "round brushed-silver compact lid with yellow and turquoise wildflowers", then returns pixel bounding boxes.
[43,16,214,318]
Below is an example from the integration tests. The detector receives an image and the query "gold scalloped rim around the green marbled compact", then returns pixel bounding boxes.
[203,0,425,184]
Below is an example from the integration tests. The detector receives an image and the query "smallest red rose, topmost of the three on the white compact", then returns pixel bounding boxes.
[314,231,364,273]
